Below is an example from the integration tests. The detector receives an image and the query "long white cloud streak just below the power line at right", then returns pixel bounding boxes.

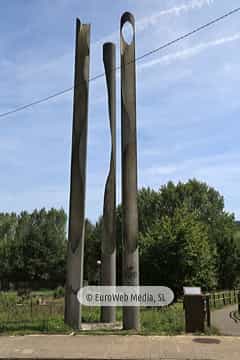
[139,32,240,69]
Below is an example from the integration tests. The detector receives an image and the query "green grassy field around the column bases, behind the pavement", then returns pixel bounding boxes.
[0,292,216,335]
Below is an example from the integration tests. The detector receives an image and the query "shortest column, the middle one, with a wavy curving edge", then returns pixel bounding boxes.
[101,43,116,323]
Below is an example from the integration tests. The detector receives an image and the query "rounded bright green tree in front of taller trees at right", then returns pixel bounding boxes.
[140,207,216,294]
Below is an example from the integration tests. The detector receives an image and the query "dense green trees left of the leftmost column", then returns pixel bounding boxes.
[0,209,67,288]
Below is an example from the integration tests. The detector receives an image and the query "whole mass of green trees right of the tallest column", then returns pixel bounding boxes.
[113,179,237,289]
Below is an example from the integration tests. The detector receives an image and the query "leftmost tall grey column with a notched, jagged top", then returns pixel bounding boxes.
[65,19,90,329]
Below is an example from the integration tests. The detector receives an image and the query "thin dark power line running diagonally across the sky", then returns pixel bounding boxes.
[0,7,240,118]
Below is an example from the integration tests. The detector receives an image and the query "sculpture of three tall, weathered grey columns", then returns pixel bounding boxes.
[65,12,140,329]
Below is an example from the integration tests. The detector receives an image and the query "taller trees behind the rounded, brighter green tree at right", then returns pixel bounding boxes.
[114,179,236,288]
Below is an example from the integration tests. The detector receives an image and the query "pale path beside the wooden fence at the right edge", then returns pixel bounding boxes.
[211,305,240,336]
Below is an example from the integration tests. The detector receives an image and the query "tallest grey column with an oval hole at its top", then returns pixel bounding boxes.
[120,12,140,329]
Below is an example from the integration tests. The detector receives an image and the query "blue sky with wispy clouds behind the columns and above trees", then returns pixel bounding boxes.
[0,0,240,221]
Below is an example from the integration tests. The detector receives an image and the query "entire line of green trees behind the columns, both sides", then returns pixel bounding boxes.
[0,179,240,292]
